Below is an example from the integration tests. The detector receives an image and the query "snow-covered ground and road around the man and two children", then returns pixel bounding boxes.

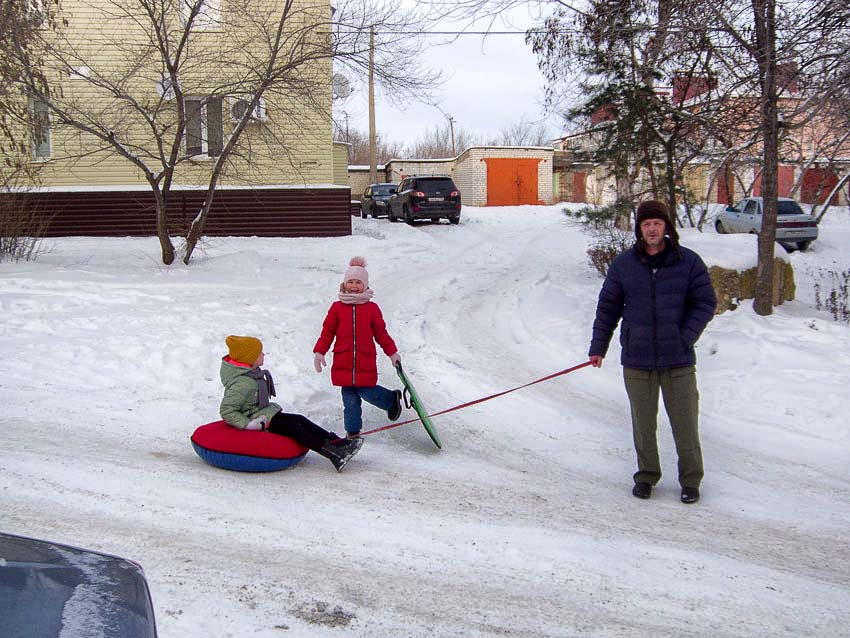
[0,207,850,638]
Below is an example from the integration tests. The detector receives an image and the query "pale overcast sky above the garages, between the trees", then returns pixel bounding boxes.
[335,7,561,148]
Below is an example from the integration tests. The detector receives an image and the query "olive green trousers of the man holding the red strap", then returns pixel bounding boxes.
[623,366,703,487]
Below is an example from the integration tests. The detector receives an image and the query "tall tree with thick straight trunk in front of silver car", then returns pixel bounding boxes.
[705,0,850,315]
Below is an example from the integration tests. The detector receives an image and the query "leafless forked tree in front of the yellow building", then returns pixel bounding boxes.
[8,0,432,264]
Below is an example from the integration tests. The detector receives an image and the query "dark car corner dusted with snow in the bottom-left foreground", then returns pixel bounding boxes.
[0,534,156,638]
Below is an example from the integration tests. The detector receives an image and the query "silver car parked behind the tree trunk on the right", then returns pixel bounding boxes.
[714,197,818,252]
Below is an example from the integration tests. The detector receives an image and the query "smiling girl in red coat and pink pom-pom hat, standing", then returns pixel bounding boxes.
[313,257,401,437]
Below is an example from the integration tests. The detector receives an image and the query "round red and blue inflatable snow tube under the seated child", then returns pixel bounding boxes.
[192,421,308,472]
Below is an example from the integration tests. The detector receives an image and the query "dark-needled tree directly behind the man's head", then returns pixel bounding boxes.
[516,0,744,224]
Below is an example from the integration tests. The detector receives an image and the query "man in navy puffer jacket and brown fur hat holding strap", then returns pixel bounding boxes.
[589,201,717,503]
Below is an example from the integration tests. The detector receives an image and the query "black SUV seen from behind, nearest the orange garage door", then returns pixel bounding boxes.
[389,175,460,224]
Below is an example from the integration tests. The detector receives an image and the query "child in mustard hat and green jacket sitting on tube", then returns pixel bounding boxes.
[219,335,363,472]
